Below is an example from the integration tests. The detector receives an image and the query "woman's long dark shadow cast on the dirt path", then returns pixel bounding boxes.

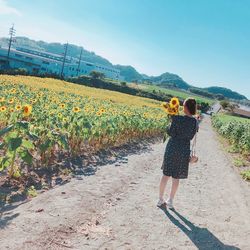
[161,206,240,250]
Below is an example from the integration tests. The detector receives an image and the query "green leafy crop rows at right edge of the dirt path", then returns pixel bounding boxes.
[212,114,250,180]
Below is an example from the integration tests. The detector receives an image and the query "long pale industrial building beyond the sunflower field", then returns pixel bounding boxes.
[0,48,121,80]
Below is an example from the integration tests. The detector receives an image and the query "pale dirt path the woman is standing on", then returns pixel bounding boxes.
[0,117,250,250]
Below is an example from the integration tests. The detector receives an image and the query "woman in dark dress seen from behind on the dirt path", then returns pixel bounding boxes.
[157,98,198,208]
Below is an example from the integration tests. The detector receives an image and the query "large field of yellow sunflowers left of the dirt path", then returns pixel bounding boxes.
[0,75,168,177]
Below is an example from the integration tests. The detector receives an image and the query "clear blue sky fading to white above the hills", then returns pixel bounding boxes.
[0,0,250,98]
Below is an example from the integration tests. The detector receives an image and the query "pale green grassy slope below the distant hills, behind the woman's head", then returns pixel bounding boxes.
[141,84,215,105]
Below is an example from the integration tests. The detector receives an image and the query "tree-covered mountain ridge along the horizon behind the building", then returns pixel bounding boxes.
[0,37,247,100]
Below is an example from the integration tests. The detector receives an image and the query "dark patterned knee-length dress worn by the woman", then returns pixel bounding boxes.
[162,115,198,179]
